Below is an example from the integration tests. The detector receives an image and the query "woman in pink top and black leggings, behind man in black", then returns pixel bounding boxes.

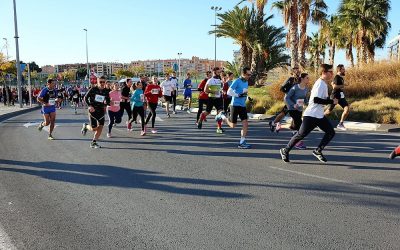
[107,83,122,138]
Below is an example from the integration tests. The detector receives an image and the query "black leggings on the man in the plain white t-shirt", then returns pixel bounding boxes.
[286,116,335,152]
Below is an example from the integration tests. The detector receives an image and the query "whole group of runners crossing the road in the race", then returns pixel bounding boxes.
[34,64,400,162]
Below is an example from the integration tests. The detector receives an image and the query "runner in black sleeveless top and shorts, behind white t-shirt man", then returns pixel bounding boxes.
[325,64,350,131]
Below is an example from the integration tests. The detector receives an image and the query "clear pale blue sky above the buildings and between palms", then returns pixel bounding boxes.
[0,0,400,66]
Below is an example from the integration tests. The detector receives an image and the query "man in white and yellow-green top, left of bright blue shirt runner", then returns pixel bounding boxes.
[197,67,223,134]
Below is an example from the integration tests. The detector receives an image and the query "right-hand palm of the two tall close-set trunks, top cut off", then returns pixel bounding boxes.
[299,0,328,69]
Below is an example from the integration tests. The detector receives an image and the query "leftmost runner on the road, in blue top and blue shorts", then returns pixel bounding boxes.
[38,79,60,140]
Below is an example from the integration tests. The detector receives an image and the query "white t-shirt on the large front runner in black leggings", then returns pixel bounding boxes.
[303,78,329,119]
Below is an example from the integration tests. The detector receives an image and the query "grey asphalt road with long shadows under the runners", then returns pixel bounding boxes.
[0,106,400,249]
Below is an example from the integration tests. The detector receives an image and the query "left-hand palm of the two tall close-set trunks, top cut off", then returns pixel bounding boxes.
[272,0,299,67]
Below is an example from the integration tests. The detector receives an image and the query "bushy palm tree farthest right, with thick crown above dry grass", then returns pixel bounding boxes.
[339,0,391,64]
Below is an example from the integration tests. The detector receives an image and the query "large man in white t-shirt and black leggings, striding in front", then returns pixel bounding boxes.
[280,64,338,162]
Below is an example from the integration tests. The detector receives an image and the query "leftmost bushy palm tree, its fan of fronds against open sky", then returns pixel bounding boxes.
[209,6,253,66]
